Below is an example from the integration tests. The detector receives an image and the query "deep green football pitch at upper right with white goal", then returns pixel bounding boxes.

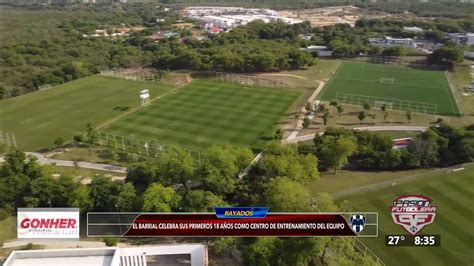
[319,63,459,116]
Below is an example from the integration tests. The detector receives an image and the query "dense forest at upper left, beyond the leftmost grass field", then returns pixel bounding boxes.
[0,5,177,98]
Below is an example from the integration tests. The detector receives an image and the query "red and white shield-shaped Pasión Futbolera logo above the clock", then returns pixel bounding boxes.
[390,195,436,235]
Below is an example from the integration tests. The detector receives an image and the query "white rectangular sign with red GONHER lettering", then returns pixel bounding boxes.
[17,208,79,238]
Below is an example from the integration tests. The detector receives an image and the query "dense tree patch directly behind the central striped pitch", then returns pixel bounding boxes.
[143,21,312,72]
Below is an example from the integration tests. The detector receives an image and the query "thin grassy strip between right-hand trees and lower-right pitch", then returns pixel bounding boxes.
[309,169,427,194]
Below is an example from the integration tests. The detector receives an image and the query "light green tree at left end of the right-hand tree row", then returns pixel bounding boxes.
[318,136,357,174]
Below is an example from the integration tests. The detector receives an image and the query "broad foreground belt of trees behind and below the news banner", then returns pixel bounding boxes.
[0,143,377,265]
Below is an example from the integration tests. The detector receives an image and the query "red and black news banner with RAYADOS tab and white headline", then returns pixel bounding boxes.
[87,207,378,237]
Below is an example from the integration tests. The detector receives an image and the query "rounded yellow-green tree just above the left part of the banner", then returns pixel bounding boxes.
[142,183,181,212]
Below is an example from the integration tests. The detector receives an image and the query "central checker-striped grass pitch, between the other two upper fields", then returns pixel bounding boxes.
[105,80,301,150]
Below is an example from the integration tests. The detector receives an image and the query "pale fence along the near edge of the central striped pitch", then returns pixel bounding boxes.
[95,131,201,163]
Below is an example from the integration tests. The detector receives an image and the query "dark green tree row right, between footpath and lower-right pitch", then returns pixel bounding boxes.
[299,124,474,171]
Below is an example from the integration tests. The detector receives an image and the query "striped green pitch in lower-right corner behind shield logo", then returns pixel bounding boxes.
[345,165,474,265]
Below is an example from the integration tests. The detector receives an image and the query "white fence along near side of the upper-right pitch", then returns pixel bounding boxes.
[336,93,438,114]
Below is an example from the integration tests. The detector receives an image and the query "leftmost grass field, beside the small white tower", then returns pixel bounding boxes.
[0,76,169,151]
